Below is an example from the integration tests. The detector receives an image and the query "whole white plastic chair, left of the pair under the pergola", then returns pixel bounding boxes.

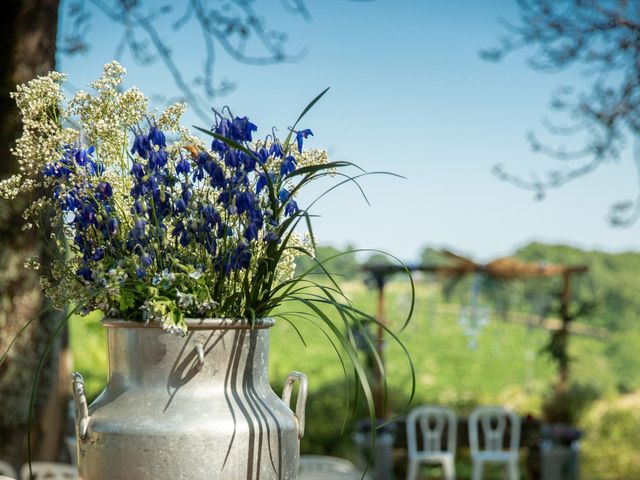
[407,406,458,480]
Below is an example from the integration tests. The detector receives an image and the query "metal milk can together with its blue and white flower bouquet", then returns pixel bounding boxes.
[0,62,412,479]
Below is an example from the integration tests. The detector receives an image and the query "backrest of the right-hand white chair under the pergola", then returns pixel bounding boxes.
[469,407,520,455]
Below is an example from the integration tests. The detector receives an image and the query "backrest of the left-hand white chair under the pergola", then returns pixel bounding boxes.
[407,405,458,457]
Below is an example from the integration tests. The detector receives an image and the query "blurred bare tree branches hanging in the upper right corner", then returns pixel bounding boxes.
[481,0,640,226]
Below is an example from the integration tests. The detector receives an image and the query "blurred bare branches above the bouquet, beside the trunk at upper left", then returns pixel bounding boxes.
[59,0,311,122]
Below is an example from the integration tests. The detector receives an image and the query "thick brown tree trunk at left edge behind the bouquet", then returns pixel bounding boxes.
[0,0,69,467]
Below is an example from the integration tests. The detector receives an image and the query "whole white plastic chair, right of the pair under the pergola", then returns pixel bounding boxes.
[469,407,520,480]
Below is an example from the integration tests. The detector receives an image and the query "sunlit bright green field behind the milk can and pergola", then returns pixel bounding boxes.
[71,281,640,478]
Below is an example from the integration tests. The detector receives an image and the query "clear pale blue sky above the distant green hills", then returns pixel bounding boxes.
[58,0,640,261]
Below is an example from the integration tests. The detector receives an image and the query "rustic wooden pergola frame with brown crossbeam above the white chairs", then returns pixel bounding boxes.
[363,250,588,418]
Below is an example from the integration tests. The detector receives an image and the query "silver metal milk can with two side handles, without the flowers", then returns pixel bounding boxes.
[73,319,307,480]
